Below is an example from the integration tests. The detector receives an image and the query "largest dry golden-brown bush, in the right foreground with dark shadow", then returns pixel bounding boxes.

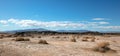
[92,42,116,53]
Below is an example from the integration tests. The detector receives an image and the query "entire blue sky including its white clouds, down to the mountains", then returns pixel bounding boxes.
[0,0,120,31]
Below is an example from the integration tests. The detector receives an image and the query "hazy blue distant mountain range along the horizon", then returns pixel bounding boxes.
[1,28,120,33]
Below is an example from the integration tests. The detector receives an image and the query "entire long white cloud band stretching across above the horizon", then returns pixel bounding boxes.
[0,18,120,29]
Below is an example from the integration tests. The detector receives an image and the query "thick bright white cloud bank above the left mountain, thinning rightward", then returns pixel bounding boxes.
[2,18,84,27]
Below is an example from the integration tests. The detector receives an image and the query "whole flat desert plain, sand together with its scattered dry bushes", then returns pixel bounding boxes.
[0,34,120,56]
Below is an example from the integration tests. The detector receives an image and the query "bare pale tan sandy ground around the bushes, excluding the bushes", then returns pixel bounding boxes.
[0,35,120,56]
